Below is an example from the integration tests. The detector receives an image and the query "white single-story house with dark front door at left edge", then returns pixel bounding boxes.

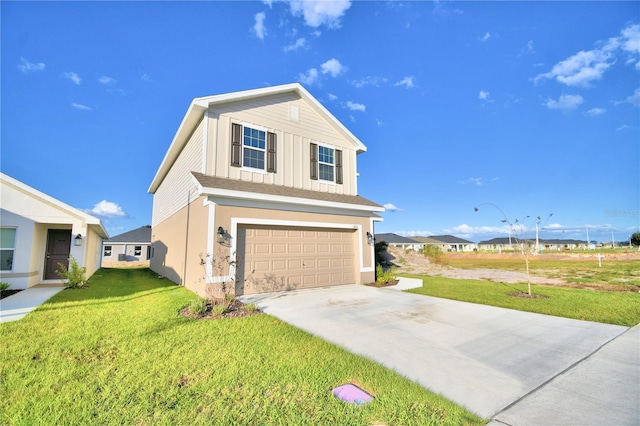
[0,173,109,289]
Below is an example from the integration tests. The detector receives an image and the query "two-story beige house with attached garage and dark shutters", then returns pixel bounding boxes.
[149,83,384,296]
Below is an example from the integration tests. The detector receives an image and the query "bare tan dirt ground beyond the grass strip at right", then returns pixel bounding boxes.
[388,246,640,291]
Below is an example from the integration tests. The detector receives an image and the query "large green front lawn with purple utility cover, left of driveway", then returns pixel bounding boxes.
[0,269,485,425]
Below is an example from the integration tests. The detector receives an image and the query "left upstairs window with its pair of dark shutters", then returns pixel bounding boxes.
[231,124,276,173]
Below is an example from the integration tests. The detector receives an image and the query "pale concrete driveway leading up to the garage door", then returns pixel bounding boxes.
[242,279,640,425]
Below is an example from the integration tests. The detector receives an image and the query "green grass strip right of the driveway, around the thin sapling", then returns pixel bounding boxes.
[409,276,640,327]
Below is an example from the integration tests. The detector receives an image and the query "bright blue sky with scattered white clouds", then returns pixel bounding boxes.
[0,1,640,241]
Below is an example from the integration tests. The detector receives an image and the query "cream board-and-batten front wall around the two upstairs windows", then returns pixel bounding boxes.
[204,93,357,195]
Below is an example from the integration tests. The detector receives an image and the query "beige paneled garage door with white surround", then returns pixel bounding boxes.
[237,226,356,294]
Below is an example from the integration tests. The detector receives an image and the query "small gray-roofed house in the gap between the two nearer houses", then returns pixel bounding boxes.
[102,225,151,268]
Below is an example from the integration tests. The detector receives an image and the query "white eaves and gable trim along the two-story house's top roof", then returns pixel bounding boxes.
[148,83,367,194]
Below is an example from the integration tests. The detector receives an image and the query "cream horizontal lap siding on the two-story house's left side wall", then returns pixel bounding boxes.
[151,121,204,227]
